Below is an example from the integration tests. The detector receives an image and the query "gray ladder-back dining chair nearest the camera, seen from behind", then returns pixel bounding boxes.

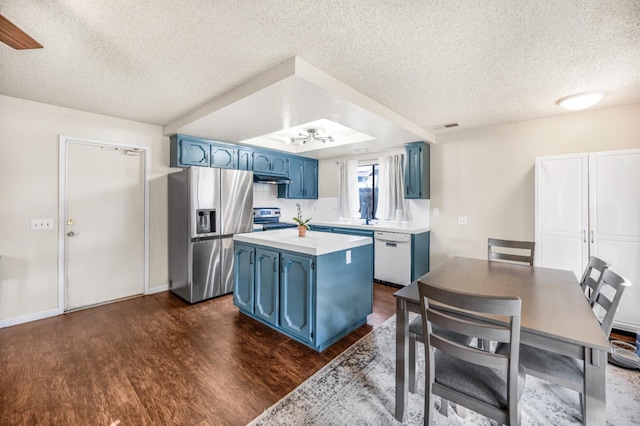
[418,281,525,425]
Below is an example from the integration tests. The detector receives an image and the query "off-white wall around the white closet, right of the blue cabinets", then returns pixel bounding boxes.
[430,104,640,268]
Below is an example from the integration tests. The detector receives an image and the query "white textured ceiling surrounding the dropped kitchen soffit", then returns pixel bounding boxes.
[0,0,640,151]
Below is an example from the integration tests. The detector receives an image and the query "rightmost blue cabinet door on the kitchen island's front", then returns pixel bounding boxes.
[280,253,313,342]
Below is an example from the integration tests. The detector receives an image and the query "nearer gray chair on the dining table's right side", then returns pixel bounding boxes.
[496,269,631,418]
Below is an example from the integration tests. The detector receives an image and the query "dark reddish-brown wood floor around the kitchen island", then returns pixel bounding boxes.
[0,284,397,425]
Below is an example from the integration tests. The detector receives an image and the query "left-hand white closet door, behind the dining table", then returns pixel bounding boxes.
[534,154,589,279]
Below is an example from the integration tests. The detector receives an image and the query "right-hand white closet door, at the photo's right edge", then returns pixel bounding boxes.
[589,150,640,331]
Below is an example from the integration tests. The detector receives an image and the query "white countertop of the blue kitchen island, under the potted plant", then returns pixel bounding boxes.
[233,228,373,256]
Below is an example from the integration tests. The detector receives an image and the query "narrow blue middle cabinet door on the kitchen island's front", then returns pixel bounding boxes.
[254,248,280,325]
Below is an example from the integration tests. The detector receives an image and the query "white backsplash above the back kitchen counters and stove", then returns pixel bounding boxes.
[253,183,430,226]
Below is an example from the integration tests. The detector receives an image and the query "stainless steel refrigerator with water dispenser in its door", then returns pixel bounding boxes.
[168,167,253,303]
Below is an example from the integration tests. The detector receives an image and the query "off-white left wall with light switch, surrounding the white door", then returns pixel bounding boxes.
[0,96,171,324]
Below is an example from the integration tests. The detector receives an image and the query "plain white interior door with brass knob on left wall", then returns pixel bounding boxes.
[64,140,145,310]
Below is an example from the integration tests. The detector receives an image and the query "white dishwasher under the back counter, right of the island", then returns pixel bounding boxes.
[373,232,411,285]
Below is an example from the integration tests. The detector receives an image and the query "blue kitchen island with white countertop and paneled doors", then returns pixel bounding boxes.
[233,229,373,351]
